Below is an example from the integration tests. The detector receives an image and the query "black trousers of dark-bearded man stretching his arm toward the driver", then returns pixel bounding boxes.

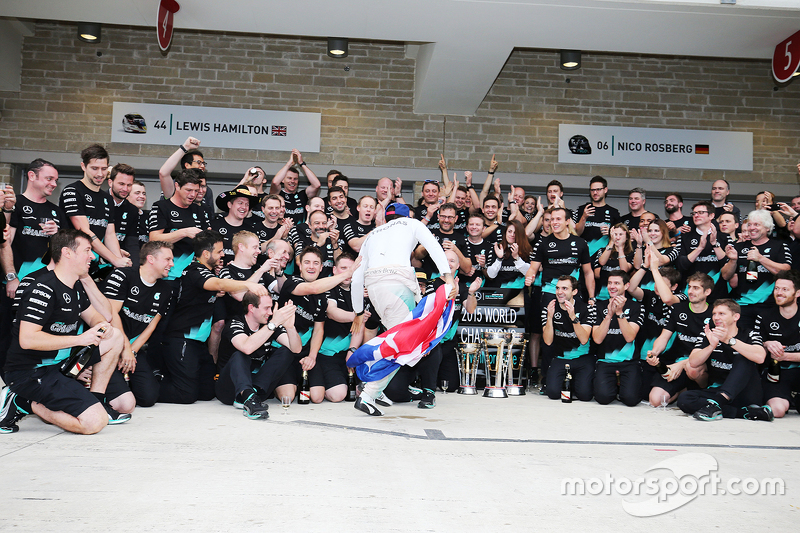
[158,337,216,403]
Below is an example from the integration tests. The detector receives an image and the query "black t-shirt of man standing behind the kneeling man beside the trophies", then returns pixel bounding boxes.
[531,235,592,294]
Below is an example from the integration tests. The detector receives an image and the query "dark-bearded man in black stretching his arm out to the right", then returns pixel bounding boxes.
[158,230,268,403]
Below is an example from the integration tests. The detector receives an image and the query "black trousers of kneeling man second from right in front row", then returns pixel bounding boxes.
[678,354,763,418]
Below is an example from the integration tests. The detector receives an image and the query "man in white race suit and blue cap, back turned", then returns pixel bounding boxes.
[350,203,457,416]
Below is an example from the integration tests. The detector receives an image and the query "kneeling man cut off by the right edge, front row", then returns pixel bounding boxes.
[761,270,800,418]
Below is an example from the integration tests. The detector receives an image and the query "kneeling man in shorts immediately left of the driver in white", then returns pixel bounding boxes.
[309,252,364,403]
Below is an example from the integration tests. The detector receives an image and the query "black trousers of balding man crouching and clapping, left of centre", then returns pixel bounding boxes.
[215,346,295,405]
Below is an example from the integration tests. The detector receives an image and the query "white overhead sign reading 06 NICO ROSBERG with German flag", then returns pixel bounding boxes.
[558,124,753,170]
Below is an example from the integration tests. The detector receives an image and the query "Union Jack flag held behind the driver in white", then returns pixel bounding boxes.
[347,285,454,381]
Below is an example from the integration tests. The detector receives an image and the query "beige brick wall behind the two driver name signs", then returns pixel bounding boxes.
[0,23,800,189]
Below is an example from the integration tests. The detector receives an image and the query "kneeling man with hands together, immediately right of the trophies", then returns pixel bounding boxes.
[542,276,595,402]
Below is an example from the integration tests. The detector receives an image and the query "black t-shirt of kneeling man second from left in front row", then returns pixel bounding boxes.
[103,267,172,342]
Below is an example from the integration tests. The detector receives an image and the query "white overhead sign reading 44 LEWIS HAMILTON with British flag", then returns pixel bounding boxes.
[111,102,321,152]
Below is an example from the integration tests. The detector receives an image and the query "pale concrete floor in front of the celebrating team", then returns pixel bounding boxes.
[0,386,800,532]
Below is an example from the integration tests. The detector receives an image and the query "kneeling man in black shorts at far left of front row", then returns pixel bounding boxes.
[0,229,130,435]
